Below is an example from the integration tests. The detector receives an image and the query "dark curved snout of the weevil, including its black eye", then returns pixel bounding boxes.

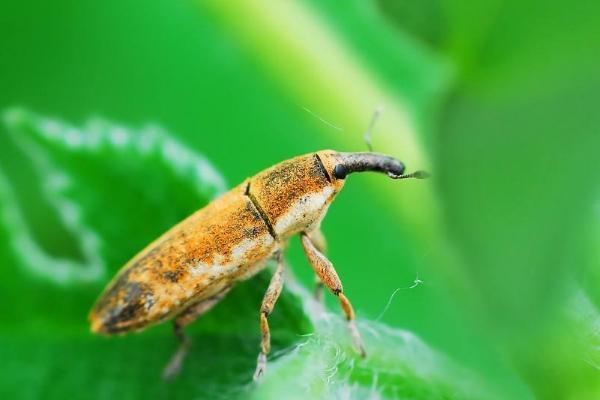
[333,152,404,179]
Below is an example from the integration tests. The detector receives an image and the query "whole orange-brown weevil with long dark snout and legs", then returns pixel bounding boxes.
[89,150,426,379]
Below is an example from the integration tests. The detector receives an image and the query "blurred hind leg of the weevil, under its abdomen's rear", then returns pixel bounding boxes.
[162,287,231,380]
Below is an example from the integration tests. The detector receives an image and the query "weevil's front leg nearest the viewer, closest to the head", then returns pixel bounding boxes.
[302,233,366,357]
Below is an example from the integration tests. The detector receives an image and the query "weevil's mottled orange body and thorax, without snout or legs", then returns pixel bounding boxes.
[90,150,345,334]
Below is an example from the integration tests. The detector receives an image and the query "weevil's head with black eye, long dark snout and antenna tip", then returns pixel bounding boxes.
[317,150,428,181]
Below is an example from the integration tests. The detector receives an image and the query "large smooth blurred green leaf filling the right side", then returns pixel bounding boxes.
[426,1,600,398]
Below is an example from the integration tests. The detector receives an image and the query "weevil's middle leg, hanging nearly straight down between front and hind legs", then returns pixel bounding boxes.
[254,251,285,381]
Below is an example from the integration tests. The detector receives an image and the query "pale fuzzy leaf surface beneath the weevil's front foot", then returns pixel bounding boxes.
[244,280,489,400]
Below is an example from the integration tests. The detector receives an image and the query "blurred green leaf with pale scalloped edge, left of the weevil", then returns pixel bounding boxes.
[2,109,225,284]
